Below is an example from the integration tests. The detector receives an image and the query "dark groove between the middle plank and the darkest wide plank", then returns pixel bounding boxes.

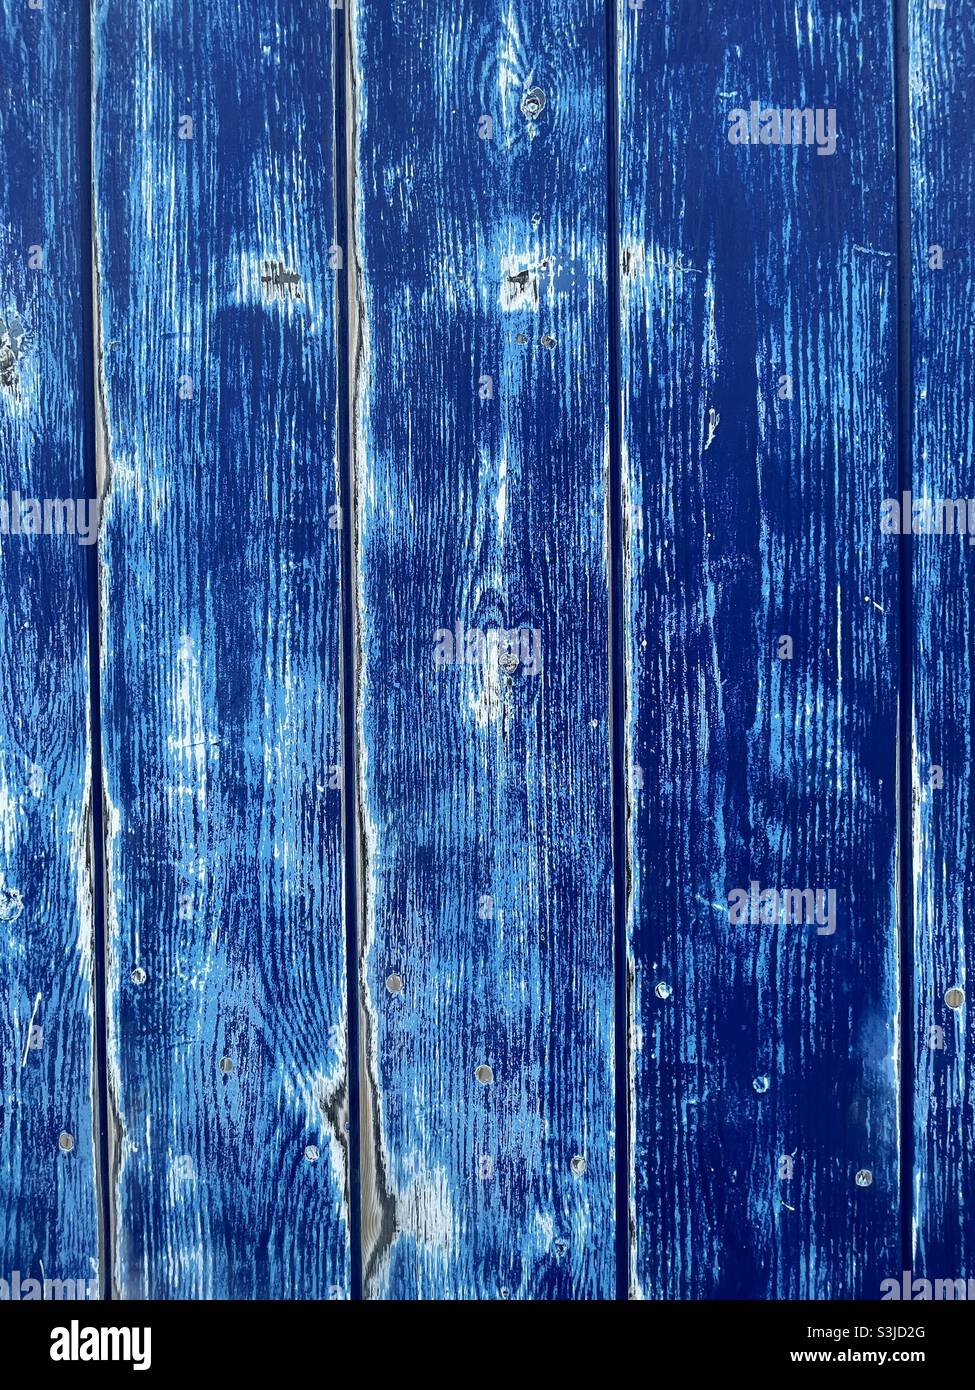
[606,0,630,1300]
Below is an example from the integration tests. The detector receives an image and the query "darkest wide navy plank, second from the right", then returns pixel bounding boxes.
[619,0,900,1298]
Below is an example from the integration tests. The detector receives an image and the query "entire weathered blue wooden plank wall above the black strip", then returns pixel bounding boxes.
[0,0,975,1300]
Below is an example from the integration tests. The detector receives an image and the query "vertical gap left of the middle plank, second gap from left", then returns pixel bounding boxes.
[336,0,362,1301]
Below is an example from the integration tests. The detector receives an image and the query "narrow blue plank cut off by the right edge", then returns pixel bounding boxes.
[908,0,975,1279]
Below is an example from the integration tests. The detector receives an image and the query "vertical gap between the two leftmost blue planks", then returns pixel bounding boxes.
[78,4,114,1300]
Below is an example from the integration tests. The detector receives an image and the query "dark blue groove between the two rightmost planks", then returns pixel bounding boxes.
[894,0,915,1269]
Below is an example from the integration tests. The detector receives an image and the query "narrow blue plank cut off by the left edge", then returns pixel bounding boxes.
[0,0,99,1297]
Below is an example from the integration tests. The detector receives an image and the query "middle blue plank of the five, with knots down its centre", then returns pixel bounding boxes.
[352,0,615,1298]
